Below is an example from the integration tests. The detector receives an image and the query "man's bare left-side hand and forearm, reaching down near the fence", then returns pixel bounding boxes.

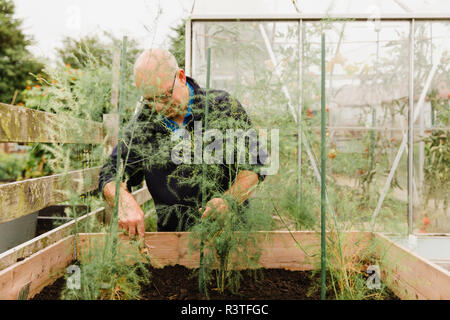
[103,181,145,239]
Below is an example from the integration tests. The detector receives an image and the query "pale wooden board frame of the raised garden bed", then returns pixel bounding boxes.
[0,231,450,300]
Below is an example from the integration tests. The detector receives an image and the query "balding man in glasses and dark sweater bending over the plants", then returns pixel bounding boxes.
[99,49,264,237]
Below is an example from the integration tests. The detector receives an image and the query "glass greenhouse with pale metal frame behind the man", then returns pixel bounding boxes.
[186,1,450,233]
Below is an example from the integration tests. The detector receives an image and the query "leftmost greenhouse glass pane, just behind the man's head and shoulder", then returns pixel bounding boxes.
[192,22,320,230]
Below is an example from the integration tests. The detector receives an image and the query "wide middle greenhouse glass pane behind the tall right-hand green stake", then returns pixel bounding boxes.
[302,22,409,232]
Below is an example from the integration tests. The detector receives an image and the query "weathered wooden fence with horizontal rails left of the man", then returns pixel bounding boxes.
[0,103,151,270]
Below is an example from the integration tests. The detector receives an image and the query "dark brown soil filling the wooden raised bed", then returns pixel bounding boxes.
[33,265,398,300]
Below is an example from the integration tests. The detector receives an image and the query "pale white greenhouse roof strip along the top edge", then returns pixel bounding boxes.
[191,0,450,20]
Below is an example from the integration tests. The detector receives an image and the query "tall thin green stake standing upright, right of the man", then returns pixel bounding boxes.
[320,31,326,300]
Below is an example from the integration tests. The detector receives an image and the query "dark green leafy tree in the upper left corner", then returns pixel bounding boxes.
[0,0,43,103]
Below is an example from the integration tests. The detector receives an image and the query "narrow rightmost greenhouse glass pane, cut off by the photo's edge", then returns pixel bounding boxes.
[413,22,450,233]
